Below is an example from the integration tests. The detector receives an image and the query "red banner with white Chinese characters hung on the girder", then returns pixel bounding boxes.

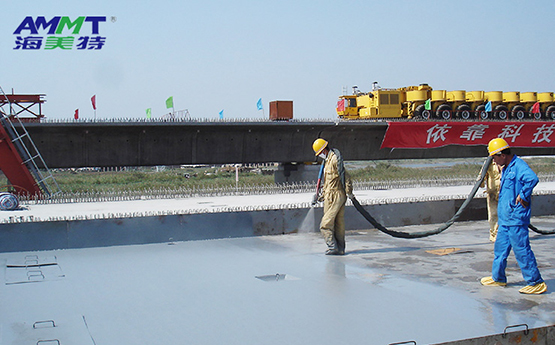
[381,121,555,148]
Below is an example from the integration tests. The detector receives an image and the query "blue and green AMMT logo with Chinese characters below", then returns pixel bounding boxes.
[13,16,106,50]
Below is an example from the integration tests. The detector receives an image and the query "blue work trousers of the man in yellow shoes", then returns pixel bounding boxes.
[492,225,543,285]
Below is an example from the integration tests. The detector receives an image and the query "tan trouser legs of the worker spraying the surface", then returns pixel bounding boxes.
[320,192,347,253]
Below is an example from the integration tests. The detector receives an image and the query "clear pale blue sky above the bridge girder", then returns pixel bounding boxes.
[0,0,555,119]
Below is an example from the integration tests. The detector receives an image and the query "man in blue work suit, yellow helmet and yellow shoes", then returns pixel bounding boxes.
[481,138,547,294]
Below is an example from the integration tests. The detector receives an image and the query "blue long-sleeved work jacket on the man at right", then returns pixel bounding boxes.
[497,155,538,226]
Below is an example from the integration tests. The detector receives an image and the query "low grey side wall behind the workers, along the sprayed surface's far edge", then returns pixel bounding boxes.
[0,194,555,252]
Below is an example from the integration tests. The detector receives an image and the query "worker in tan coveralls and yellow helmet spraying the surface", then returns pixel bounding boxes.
[312,138,353,255]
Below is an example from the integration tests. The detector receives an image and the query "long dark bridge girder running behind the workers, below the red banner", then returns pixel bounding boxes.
[19,121,555,168]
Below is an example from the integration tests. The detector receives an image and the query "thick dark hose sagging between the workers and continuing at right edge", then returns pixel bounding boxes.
[351,156,555,238]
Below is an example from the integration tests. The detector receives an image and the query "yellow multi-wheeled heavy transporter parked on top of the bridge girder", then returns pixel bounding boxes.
[336,82,555,120]
